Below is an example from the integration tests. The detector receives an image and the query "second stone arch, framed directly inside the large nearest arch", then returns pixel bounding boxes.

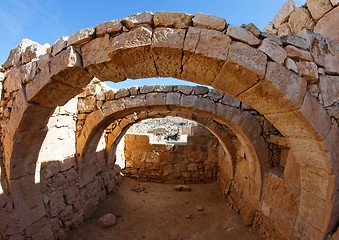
[77,86,270,208]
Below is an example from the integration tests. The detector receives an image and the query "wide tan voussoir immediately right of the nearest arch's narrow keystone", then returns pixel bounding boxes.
[181,28,231,85]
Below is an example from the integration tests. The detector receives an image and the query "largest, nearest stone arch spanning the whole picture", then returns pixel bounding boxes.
[3,10,339,239]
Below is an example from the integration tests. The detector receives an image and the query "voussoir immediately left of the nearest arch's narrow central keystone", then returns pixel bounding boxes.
[109,27,158,79]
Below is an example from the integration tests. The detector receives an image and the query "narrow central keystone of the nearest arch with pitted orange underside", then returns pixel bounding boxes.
[151,27,186,78]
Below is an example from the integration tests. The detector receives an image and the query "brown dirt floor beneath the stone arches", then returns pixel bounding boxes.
[68,178,259,240]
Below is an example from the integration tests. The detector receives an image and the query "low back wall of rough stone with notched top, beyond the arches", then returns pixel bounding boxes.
[123,127,220,183]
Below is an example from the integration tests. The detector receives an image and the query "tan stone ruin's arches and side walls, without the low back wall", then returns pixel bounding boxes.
[0,0,339,240]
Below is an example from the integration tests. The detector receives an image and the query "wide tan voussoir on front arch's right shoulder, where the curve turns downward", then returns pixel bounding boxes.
[239,62,307,114]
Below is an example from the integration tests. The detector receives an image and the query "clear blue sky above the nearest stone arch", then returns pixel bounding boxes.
[0,0,305,88]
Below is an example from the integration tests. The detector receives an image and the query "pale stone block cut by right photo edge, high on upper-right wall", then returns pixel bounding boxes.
[314,7,339,43]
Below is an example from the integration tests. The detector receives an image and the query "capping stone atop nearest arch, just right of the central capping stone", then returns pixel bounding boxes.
[192,13,226,31]
